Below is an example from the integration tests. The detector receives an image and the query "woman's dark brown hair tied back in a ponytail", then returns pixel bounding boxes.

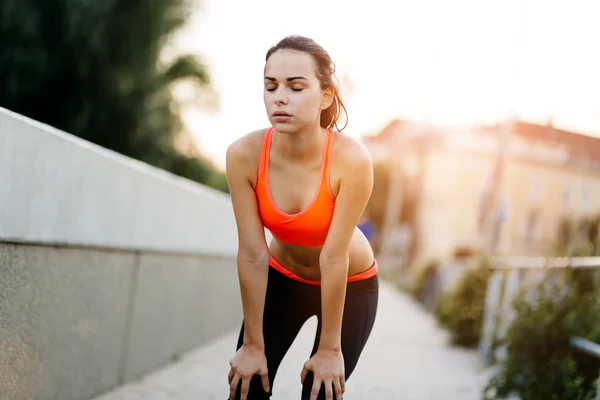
[265,35,348,131]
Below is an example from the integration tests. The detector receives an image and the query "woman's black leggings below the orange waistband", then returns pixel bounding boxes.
[236,267,379,400]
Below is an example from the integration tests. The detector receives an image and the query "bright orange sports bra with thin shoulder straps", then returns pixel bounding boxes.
[254,128,335,246]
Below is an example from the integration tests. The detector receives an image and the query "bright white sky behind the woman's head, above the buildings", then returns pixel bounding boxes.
[168,0,600,166]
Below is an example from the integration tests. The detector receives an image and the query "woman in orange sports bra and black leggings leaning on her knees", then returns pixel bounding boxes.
[226,36,378,400]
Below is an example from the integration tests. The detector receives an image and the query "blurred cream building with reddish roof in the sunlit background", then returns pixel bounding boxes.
[364,120,600,266]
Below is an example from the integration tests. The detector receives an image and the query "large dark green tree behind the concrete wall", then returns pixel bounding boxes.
[0,0,227,191]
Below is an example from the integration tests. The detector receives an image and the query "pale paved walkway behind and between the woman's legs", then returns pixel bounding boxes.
[91,282,485,400]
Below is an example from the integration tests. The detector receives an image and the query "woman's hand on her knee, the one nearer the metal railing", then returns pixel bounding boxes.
[301,349,346,400]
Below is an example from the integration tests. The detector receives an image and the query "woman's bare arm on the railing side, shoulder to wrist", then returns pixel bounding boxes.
[319,142,373,350]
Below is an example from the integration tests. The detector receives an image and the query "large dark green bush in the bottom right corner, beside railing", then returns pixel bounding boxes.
[486,269,600,400]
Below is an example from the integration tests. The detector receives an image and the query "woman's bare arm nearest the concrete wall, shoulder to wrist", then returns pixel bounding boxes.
[226,136,269,350]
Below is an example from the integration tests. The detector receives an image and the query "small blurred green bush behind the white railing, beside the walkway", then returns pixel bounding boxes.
[435,261,492,347]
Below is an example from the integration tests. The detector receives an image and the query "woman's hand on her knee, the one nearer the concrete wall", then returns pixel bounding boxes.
[227,346,269,400]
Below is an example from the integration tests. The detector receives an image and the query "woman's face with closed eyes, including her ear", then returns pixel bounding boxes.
[264,49,333,133]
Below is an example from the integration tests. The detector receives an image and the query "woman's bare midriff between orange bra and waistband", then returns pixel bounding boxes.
[269,228,374,281]
